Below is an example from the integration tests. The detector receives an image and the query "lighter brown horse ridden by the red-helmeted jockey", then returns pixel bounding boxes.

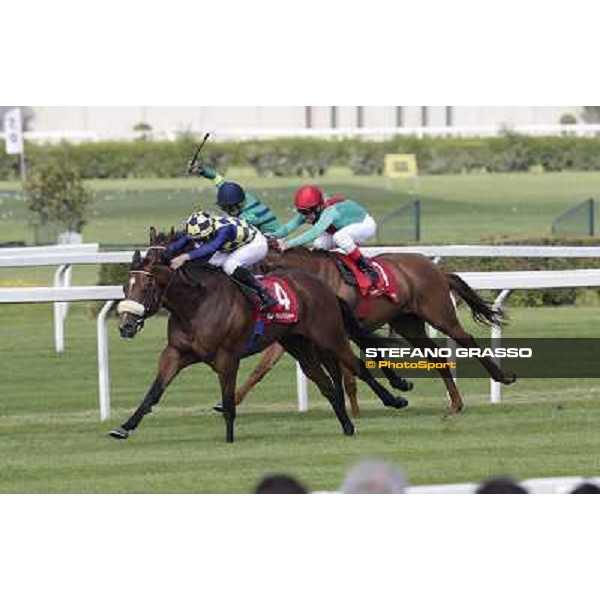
[237,248,516,417]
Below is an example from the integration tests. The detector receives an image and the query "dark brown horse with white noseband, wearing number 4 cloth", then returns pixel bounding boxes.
[110,229,408,443]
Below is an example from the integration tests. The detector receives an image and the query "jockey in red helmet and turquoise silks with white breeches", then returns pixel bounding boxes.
[275,186,379,286]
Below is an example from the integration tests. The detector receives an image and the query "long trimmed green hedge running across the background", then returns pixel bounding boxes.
[5,134,600,180]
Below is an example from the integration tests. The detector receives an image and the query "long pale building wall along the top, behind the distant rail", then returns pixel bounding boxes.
[29,106,582,138]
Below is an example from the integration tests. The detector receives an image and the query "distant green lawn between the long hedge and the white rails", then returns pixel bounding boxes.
[0,169,600,244]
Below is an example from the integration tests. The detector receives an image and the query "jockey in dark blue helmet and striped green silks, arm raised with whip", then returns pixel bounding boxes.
[190,163,280,234]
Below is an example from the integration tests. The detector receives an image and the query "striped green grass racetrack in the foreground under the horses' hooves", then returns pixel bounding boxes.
[0,306,600,493]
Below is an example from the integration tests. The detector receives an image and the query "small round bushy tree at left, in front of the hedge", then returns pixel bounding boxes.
[25,159,93,233]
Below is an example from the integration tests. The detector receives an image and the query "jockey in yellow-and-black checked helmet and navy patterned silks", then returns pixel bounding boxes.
[167,212,277,310]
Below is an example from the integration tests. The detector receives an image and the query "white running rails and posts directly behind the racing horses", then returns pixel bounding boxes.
[0,244,600,420]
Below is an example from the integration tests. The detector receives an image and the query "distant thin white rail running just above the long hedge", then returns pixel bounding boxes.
[0,123,600,144]
